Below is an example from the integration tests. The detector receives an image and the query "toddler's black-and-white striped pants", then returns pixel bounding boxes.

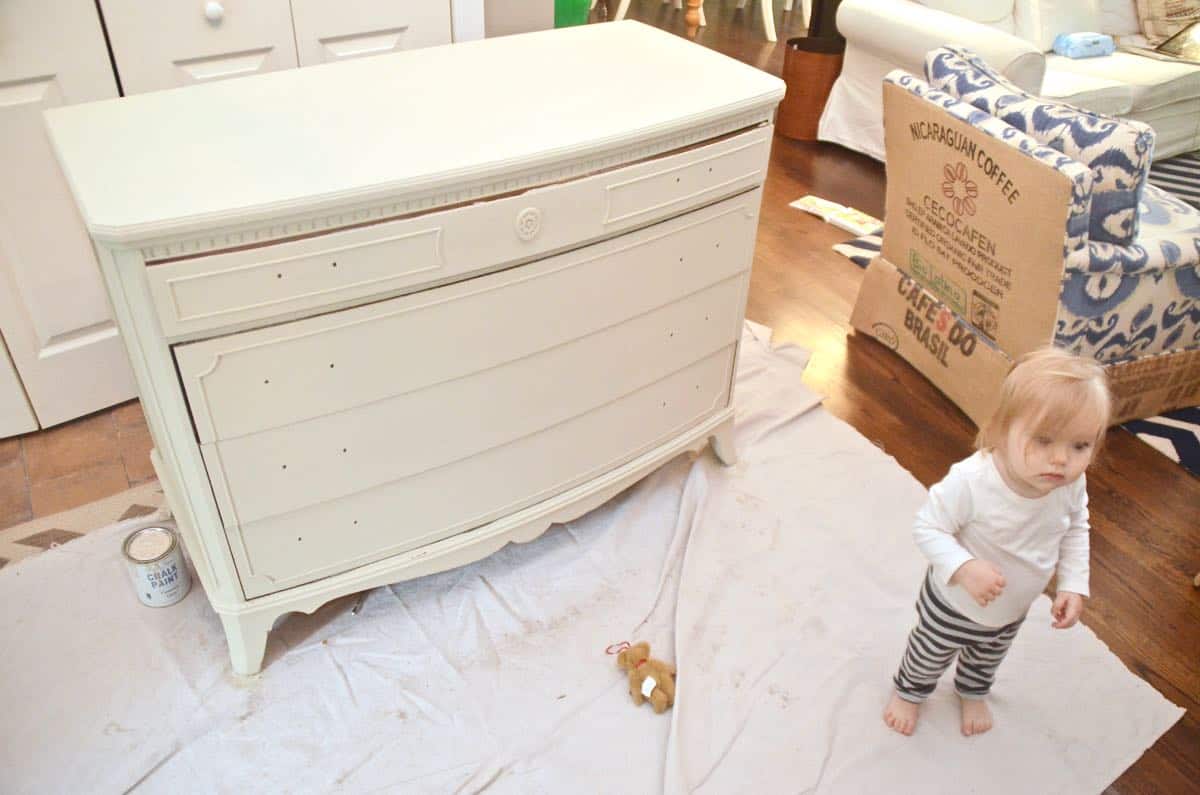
[892,569,1025,704]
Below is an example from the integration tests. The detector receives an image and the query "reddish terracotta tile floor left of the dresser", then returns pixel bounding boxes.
[0,400,155,530]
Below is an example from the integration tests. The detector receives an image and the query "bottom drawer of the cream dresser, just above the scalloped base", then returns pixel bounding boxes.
[220,346,734,598]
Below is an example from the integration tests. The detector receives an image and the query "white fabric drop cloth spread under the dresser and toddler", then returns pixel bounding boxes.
[0,327,1182,794]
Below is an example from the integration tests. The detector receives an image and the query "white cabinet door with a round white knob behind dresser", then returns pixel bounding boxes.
[100,0,296,96]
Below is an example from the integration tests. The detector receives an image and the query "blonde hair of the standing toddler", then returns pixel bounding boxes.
[976,346,1112,452]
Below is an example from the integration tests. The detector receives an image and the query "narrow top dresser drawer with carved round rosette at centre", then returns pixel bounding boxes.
[146,127,770,341]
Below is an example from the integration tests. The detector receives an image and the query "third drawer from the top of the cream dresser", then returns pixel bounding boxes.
[203,276,743,526]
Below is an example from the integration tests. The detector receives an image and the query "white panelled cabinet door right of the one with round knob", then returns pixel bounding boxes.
[292,0,450,66]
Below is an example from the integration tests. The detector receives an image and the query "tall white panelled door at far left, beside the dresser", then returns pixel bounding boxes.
[0,0,136,435]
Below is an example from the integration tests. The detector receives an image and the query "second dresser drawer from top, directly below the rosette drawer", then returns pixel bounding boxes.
[173,190,761,443]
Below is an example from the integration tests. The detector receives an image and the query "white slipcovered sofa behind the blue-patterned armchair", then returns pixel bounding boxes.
[817,0,1200,160]
